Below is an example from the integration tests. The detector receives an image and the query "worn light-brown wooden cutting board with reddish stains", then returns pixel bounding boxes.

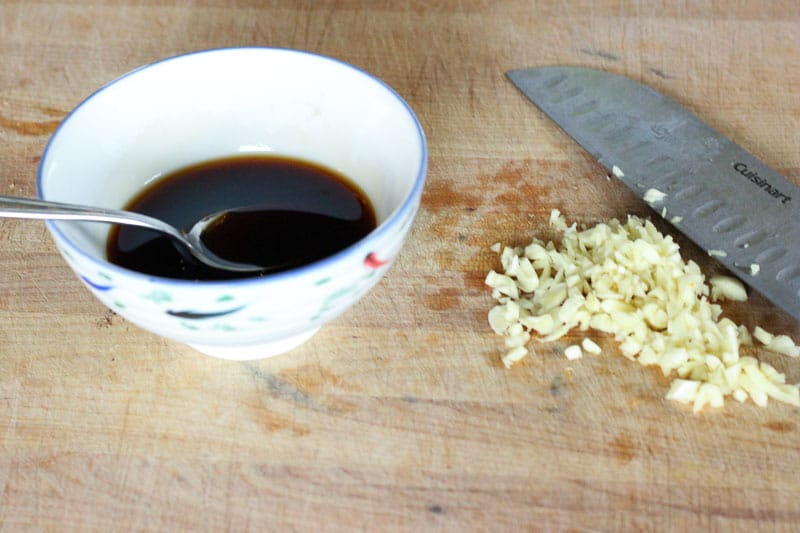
[0,0,800,531]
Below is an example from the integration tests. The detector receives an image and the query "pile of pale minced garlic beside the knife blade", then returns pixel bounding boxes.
[486,210,800,412]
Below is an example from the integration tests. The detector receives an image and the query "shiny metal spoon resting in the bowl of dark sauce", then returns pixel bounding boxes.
[0,196,267,272]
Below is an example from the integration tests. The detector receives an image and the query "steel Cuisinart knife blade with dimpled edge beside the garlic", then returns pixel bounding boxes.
[507,66,800,320]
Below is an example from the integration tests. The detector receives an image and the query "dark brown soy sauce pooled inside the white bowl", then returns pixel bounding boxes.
[106,155,376,280]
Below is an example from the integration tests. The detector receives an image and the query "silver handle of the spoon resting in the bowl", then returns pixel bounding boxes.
[0,195,180,237]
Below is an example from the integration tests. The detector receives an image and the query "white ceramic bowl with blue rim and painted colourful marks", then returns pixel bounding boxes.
[38,48,427,360]
